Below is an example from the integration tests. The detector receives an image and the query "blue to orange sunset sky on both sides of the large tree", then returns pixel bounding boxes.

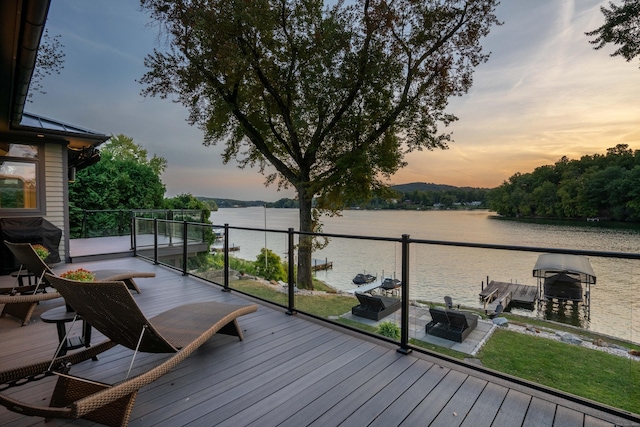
[25,0,640,201]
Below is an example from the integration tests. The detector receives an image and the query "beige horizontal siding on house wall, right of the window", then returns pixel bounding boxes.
[44,144,69,262]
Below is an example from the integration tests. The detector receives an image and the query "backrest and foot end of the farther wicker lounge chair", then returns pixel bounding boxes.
[4,240,156,293]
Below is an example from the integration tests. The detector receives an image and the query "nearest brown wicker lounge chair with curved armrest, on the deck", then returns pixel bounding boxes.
[0,275,257,426]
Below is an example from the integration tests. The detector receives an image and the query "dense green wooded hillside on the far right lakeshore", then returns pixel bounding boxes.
[488,144,640,222]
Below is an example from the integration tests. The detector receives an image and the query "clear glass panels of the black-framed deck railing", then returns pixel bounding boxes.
[131,220,640,413]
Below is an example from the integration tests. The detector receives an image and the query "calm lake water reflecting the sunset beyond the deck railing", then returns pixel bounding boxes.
[211,208,640,342]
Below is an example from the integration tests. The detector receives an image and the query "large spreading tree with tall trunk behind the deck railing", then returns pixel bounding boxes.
[141,0,498,287]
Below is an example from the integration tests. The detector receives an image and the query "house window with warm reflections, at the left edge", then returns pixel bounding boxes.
[0,142,41,210]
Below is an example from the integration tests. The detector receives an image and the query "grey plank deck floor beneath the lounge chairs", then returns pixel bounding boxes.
[0,258,640,427]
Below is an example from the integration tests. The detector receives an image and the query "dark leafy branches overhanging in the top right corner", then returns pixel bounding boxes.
[586,0,640,66]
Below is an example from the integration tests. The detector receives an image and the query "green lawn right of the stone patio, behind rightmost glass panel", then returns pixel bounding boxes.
[478,330,640,413]
